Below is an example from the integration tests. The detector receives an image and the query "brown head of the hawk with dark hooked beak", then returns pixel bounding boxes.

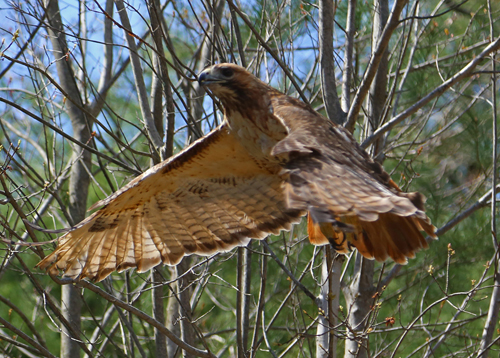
[198,63,273,112]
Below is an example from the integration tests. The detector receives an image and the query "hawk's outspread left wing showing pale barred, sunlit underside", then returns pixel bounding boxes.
[38,125,305,281]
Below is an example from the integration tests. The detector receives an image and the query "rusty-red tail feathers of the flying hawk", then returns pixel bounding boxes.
[307,213,436,264]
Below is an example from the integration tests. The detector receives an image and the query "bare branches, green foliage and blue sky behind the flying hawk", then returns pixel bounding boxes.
[0,0,500,358]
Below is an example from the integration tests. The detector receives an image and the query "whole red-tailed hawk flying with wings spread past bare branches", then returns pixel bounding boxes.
[38,64,435,281]
